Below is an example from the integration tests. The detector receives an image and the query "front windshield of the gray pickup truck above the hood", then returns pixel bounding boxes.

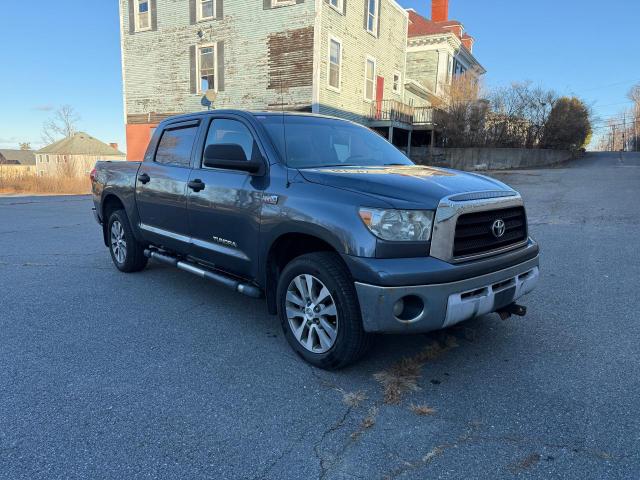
[256,115,413,168]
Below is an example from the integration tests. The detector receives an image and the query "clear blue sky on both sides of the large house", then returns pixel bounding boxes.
[0,0,640,148]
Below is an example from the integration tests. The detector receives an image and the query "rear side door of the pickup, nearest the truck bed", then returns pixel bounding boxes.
[136,120,200,254]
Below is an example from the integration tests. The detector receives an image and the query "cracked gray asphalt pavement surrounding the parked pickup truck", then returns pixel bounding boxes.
[0,155,640,480]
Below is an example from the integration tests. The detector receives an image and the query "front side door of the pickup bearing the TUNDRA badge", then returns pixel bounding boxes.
[189,115,268,278]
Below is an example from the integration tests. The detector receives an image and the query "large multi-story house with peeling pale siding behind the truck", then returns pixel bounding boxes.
[120,0,480,160]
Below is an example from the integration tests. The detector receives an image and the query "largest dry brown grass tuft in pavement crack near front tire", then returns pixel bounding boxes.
[373,336,458,405]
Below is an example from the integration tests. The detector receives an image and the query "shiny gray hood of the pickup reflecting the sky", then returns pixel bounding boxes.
[300,165,512,209]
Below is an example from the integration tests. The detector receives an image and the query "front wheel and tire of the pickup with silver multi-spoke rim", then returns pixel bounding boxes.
[277,252,372,370]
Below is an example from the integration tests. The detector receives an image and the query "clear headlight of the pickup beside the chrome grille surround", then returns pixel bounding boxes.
[359,208,433,242]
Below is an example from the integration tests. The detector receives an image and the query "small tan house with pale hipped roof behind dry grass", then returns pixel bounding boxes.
[36,132,127,176]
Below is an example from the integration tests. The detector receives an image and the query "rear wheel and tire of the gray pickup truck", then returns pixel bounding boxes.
[107,210,149,273]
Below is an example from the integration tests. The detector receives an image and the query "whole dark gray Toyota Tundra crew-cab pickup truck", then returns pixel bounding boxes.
[91,110,539,369]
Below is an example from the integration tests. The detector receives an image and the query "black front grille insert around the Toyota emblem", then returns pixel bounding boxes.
[453,207,527,257]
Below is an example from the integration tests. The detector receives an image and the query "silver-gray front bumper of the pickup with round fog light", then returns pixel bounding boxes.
[355,255,540,333]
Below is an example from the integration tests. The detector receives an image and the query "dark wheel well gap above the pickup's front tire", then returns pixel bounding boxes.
[266,233,336,315]
